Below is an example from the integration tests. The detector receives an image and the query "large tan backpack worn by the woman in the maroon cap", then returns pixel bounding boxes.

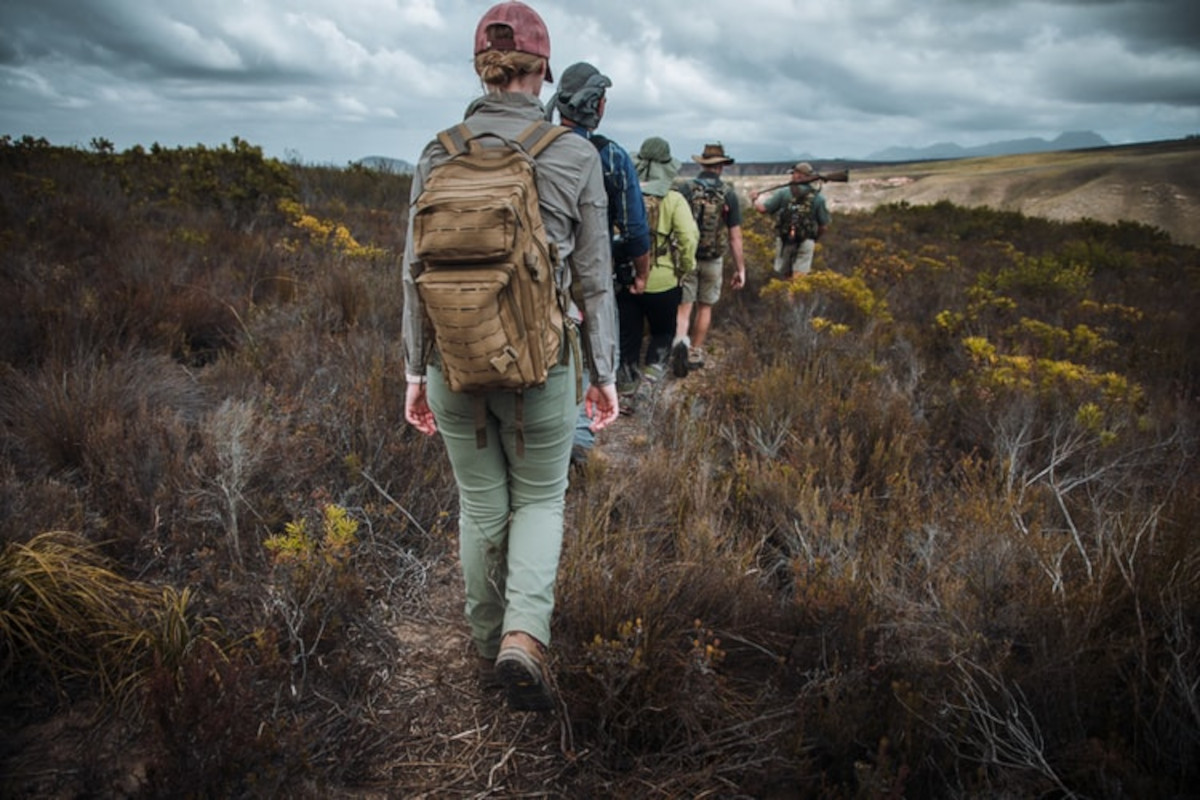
[413,122,566,392]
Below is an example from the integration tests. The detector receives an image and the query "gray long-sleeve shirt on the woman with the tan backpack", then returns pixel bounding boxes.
[403,92,617,386]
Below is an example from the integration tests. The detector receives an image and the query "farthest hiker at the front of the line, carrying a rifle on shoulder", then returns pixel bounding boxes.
[750,161,832,277]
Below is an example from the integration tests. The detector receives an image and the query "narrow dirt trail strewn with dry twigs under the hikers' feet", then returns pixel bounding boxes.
[369,355,713,799]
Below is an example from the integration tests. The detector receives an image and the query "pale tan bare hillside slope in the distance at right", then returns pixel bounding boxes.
[734,139,1200,245]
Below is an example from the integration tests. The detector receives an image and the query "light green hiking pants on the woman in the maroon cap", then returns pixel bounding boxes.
[426,352,578,657]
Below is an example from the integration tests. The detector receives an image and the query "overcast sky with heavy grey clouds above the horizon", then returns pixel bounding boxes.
[0,0,1200,166]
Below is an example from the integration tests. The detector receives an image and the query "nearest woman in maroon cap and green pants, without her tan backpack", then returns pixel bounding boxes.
[403,0,618,710]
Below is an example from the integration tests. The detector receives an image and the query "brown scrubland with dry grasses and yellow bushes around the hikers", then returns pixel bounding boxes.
[0,138,1200,798]
